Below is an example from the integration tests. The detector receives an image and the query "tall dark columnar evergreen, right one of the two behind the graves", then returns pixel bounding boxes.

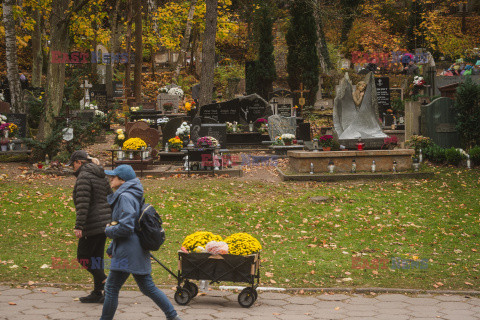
[286,0,319,105]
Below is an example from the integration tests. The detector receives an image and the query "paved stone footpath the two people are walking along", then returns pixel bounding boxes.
[0,286,480,320]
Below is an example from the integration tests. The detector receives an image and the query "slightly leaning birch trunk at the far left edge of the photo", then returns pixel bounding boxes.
[3,0,25,113]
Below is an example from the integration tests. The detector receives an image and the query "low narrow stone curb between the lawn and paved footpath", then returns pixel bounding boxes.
[0,282,480,296]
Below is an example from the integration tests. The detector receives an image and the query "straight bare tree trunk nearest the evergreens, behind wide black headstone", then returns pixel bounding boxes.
[198,0,218,112]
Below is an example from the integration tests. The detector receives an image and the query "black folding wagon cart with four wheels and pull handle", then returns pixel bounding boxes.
[152,251,260,308]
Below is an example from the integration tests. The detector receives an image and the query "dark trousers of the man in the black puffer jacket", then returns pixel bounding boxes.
[77,234,107,292]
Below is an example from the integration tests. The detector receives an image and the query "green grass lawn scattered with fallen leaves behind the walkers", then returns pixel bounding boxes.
[0,168,480,289]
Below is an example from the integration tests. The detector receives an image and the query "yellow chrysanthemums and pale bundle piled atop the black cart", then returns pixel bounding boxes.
[181,231,262,256]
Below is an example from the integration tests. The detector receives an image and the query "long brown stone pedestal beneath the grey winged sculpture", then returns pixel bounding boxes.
[287,149,415,173]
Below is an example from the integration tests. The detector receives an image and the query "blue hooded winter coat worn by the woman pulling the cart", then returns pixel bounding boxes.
[105,178,152,275]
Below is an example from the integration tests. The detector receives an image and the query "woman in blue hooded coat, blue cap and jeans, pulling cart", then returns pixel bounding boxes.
[100,165,180,320]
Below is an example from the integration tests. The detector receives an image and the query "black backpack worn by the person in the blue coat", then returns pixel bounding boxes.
[135,199,165,251]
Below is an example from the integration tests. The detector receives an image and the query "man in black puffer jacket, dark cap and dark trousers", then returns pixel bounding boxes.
[69,150,112,303]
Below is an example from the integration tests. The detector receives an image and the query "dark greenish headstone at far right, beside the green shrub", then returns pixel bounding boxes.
[420,97,460,148]
